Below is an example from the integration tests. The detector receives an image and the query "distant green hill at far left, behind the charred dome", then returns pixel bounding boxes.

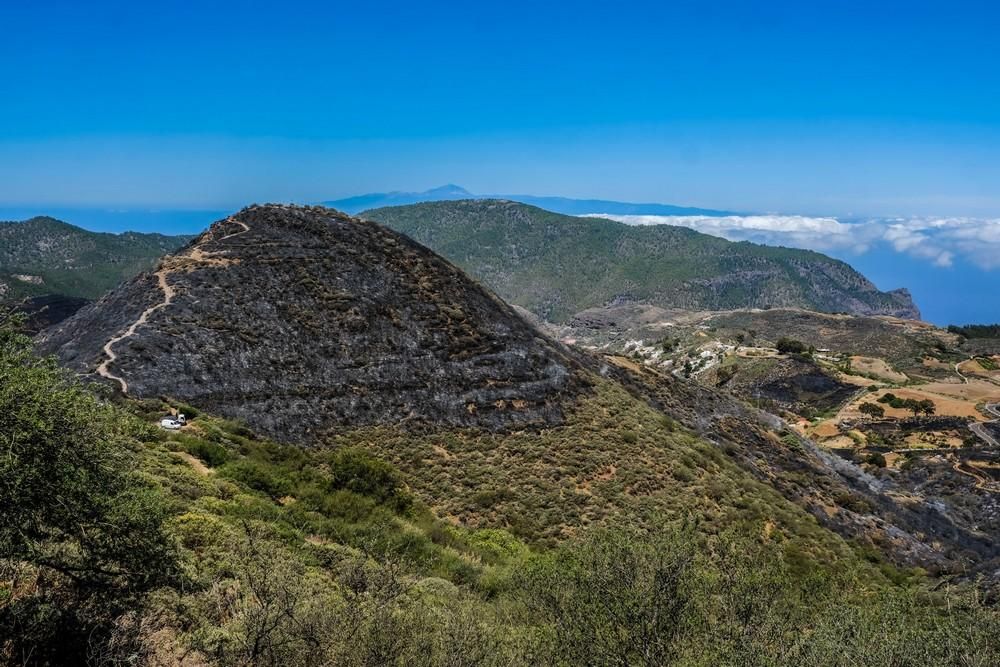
[0,217,191,300]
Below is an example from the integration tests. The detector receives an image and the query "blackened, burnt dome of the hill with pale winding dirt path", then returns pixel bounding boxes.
[39,205,585,442]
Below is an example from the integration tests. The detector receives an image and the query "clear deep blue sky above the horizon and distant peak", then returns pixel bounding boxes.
[0,1,1000,324]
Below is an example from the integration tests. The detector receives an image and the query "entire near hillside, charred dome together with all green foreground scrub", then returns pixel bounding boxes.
[15,205,998,665]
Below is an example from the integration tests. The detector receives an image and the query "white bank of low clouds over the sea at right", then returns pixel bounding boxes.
[587,213,1000,271]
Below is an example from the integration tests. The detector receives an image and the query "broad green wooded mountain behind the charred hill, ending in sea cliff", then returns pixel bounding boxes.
[361,200,919,322]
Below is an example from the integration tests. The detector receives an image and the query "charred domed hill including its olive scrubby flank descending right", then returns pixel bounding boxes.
[36,205,993,580]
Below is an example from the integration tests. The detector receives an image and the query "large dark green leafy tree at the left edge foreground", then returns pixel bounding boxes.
[0,318,176,664]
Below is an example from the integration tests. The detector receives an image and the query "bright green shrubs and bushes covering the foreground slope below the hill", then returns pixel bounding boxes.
[0,320,1000,666]
